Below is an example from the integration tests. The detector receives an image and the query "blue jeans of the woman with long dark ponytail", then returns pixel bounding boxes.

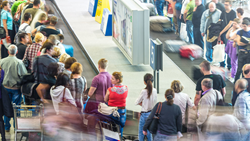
[138,112,152,141]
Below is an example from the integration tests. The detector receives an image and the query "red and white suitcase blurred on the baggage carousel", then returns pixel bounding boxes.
[180,44,203,60]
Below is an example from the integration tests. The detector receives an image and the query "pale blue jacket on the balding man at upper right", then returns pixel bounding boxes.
[200,9,221,33]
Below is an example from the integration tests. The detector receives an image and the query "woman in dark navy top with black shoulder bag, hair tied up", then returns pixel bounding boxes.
[143,89,182,141]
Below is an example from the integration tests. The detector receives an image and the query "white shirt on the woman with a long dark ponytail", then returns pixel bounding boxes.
[135,88,157,112]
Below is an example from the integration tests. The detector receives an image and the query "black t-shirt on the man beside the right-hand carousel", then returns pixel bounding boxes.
[196,74,226,96]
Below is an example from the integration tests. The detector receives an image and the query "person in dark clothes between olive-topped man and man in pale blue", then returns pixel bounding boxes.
[192,0,205,49]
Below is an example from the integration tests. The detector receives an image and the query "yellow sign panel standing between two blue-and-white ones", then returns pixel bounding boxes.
[95,0,110,23]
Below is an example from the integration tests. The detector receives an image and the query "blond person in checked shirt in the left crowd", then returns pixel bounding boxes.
[23,33,44,71]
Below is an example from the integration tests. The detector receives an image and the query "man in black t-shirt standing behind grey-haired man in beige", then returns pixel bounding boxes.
[194,61,226,105]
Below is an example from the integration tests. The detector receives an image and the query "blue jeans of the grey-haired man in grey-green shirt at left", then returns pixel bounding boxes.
[4,88,22,130]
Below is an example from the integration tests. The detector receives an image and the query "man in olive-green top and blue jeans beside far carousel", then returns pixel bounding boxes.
[183,0,195,44]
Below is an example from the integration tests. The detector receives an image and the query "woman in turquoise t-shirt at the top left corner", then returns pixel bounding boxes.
[0,1,15,58]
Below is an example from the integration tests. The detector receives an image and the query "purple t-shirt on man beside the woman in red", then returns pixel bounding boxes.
[91,72,113,102]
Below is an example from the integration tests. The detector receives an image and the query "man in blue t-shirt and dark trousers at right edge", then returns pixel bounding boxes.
[233,19,250,82]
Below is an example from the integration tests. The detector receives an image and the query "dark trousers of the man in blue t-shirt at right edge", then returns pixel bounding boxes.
[234,51,250,83]
